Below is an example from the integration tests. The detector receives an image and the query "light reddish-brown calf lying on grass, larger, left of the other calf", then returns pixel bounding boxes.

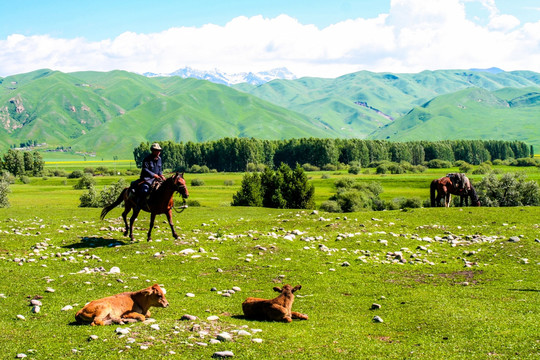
[75,284,169,326]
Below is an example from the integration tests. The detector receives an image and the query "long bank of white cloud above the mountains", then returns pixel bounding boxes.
[0,0,540,77]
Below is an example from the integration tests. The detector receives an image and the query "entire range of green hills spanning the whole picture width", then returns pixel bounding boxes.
[0,69,540,157]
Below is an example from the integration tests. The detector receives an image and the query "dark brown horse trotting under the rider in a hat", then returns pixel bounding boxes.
[101,173,189,241]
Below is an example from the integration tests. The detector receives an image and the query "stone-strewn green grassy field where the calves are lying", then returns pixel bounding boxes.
[0,168,540,359]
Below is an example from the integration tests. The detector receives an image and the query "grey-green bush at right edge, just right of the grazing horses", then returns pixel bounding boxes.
[477,173,540,206]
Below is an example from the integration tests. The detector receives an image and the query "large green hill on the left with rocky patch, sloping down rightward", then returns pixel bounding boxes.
[0,70,338,157]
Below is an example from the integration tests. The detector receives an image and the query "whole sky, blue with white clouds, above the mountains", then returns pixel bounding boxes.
[0,0,540,77]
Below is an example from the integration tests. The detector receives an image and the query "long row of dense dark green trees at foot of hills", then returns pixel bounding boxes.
[133,138,534,172]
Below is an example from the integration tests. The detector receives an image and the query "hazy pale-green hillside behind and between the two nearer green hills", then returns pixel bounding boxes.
[236,70,540,143]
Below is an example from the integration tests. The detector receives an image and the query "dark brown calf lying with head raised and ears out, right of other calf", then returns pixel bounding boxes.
[242,284,308,322]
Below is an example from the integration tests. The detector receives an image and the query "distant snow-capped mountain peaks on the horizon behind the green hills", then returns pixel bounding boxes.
[143,67,296,86]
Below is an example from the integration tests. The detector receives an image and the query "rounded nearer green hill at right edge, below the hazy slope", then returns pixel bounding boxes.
[371,88,540,149]
